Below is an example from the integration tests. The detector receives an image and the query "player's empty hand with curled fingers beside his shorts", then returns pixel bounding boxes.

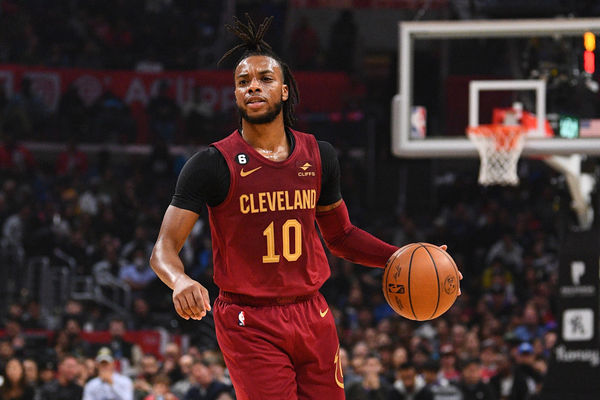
[173,275,211,320]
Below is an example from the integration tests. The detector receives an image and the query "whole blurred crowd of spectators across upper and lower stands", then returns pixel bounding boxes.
[0,0,572,400]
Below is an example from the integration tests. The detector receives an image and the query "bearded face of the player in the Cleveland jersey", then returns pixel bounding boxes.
[235,56,288,124]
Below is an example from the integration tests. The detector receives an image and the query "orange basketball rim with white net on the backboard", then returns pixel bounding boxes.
[467,124,526,185]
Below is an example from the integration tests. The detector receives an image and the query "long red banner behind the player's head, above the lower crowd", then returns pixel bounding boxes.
[0,65,351,113]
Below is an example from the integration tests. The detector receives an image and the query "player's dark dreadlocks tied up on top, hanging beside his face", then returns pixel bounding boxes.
[217,13,300,127]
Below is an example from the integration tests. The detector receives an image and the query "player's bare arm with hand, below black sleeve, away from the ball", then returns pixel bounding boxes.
[150,205,210,319]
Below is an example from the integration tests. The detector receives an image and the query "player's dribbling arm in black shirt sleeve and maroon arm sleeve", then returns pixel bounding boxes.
[316,141,398,268]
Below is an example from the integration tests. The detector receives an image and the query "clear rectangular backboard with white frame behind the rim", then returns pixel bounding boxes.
[392,18,600,158]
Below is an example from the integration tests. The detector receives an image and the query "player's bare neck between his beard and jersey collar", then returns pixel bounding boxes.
[241,118,290,161]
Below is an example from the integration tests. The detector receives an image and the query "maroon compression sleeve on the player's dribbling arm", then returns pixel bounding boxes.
[317,200,398,268]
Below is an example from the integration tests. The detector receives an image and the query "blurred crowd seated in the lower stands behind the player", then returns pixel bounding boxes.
[0,128,558,399]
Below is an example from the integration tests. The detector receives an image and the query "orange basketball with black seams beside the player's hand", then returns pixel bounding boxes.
[382,243,460,321]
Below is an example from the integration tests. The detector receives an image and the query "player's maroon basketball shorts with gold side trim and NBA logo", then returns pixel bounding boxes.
[213,293,345,400]
